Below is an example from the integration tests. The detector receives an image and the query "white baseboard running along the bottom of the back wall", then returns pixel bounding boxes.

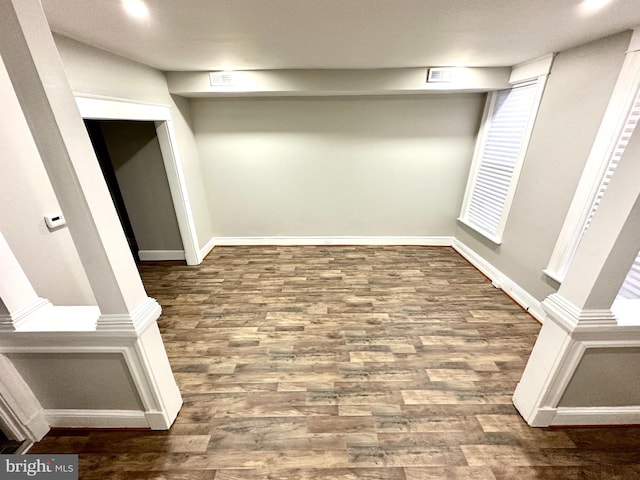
[211,236,454,247]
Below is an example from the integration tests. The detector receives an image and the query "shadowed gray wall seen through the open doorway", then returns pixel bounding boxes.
[100,121,183,250]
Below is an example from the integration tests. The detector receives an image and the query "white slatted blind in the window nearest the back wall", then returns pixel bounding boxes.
[461,83,538,237]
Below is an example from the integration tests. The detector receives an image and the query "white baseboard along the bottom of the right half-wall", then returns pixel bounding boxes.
[551,405,640,427]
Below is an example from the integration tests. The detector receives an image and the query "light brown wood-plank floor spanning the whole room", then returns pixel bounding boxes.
[31,247,640,480]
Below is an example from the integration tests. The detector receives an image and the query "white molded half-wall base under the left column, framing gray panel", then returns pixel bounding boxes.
[0,298,182,434]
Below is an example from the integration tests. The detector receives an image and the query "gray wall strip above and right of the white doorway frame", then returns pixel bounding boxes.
[54,35,213,251]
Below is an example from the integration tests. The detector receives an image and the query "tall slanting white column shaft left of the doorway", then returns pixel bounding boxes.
[0,0,150,330]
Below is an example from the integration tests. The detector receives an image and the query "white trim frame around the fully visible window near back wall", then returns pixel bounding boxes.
[458,73,551,245]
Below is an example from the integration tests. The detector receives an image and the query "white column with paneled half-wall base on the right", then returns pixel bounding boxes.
[513,124,640,426]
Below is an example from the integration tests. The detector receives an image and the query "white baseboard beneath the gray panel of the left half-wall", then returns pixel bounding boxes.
[44,409,149,428]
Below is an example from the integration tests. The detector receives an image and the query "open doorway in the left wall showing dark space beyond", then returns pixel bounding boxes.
[84,119,185,261]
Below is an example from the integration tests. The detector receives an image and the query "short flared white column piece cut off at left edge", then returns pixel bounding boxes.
[0,232,52,332]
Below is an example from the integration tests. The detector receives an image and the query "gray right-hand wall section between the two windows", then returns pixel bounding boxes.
[456,32,630,301]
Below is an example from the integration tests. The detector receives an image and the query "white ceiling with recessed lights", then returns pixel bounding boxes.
[42,0,640,71]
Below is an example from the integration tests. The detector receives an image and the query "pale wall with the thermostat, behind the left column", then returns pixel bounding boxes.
[0,52,96,305]
